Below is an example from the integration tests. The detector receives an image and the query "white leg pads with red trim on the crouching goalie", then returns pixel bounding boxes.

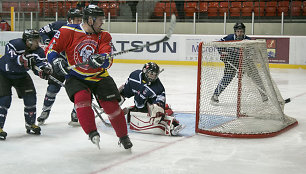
[128,104,185,136]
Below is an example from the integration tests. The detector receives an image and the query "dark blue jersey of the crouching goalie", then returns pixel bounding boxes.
[121,70,166,112]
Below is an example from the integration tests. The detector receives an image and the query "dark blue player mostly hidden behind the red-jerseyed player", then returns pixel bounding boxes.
[37,8,83,126]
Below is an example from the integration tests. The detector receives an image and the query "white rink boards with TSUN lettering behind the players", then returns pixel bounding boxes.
[0,32,306,65]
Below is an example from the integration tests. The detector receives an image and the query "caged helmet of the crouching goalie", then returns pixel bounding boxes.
[142,62,160,83]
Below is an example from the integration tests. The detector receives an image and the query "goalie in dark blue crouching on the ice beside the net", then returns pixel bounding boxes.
[119,62,184,136]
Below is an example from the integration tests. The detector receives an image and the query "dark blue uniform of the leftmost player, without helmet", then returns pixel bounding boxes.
[0,38,48,128]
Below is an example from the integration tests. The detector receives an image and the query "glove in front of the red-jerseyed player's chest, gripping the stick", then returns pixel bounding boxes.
[88,53,113,69]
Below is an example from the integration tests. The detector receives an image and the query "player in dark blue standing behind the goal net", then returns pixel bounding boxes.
[211,22,268,105]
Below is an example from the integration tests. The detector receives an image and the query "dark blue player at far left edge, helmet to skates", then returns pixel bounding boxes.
[0,29,52,139]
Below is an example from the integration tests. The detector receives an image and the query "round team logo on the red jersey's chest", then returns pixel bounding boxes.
[74,40,98,69]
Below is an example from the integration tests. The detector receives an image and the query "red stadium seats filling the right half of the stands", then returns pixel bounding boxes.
[154,0,306,17]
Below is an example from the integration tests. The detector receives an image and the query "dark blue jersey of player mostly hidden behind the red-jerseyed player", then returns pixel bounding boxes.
[39,21,68,44]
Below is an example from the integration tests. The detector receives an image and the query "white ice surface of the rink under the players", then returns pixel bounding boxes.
[0,63,306,174]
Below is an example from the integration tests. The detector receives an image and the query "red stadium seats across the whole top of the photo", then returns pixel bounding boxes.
[2,0,306,17]
